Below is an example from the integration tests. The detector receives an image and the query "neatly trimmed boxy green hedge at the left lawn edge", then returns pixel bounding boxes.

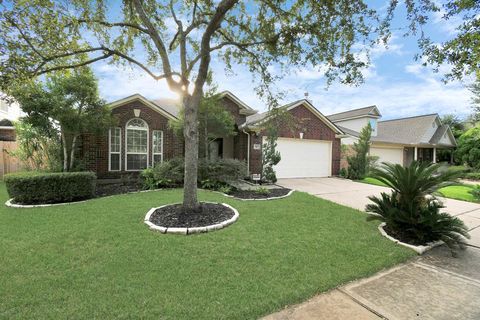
[4,172,96,204]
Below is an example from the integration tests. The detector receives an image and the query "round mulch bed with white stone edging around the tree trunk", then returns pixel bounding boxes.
[145,202,239,234]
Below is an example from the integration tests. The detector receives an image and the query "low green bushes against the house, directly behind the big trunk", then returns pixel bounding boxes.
[141,158,247,190]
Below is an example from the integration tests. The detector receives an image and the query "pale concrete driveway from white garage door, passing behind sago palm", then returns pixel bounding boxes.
[277,178,480,248]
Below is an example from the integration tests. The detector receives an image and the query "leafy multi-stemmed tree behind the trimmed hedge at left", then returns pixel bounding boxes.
[11,67,113,171]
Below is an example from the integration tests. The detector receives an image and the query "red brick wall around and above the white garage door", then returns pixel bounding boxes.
[250,105,341,175]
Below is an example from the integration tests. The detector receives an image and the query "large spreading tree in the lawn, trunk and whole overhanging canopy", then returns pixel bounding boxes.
[0,0,479,211]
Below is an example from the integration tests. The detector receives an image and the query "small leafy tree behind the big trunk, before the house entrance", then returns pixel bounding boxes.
[169,92,236,159]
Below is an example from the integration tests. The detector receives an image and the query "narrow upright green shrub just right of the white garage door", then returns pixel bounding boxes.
[347,123,373,180]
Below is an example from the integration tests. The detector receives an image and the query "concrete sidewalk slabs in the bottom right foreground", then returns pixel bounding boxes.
[263,246,480,320]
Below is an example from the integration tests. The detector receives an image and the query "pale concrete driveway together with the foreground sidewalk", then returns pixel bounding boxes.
[264,178,480,320]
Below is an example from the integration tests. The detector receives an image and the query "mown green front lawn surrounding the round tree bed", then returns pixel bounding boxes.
[0,183,414,319]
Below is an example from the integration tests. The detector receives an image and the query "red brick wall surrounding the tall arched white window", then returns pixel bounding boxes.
[81,101,183,178]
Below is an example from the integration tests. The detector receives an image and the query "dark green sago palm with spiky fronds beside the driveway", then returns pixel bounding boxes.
[366,162,469,249]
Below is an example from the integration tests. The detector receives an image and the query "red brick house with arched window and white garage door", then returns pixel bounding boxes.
[80,91,344,178]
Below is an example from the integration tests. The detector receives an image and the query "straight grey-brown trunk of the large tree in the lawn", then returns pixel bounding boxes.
[183,94,201,213]
